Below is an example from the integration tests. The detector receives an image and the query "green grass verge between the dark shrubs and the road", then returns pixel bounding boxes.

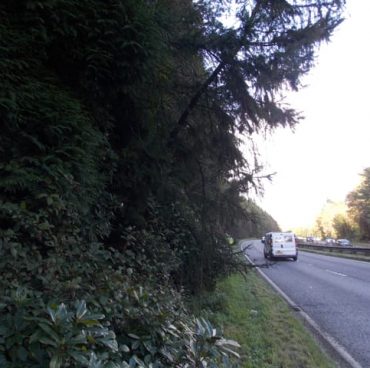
[205,271,335,368]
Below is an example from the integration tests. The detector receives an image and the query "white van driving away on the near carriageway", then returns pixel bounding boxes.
[263,232,298,261]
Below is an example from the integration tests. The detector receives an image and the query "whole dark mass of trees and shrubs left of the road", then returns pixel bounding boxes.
[0,0,343,368]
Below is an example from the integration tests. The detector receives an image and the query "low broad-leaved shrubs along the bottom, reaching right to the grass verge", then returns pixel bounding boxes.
[0,288,238,368]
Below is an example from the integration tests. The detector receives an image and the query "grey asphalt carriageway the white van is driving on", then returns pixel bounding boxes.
[244,240,370,368]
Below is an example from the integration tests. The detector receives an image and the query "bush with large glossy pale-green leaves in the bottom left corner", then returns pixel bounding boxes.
[0,300,118,368]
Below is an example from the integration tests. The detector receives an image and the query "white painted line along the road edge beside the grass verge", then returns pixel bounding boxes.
[241,243,363,368]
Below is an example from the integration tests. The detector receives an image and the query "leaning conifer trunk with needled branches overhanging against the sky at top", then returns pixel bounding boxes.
[171,0,345,139]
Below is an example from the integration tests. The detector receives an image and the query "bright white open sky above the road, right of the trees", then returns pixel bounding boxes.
[249,0,370,230]
